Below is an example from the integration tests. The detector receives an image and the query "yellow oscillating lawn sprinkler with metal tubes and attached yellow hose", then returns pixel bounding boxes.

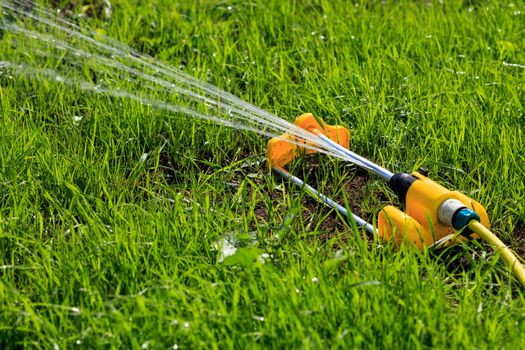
[266,113,525,287]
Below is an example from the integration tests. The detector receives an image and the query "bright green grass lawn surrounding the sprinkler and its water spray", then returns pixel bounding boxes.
[0,0,525,349]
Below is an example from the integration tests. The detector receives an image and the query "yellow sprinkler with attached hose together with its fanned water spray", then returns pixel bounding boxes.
[0,0,525,287]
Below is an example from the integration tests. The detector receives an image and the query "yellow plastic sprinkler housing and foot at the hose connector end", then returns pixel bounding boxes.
[378,172,490,250]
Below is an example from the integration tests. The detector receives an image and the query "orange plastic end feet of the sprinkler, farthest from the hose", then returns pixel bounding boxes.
[266,113,350,169]
